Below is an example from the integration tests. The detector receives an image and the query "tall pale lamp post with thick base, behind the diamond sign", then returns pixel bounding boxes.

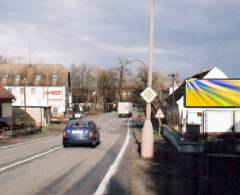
[141,0,155,158]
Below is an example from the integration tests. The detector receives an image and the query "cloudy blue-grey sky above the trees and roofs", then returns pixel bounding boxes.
[0,0,240,78]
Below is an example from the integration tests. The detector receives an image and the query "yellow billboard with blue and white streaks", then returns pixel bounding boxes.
[185,79,240,108]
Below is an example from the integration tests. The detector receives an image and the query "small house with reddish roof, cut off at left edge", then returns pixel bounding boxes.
[0,86,15,125]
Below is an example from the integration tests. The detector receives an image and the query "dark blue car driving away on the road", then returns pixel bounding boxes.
[63,119,100,147]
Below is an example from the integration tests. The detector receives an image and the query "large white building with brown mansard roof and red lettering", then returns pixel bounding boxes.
[0,64,70,126]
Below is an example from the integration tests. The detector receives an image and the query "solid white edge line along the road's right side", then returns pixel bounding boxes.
[94,120,130,195]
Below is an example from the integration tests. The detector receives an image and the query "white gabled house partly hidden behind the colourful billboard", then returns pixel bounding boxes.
[166,67,240,135]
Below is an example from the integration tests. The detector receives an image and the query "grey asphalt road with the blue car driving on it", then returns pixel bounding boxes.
[0,113,127,195]
